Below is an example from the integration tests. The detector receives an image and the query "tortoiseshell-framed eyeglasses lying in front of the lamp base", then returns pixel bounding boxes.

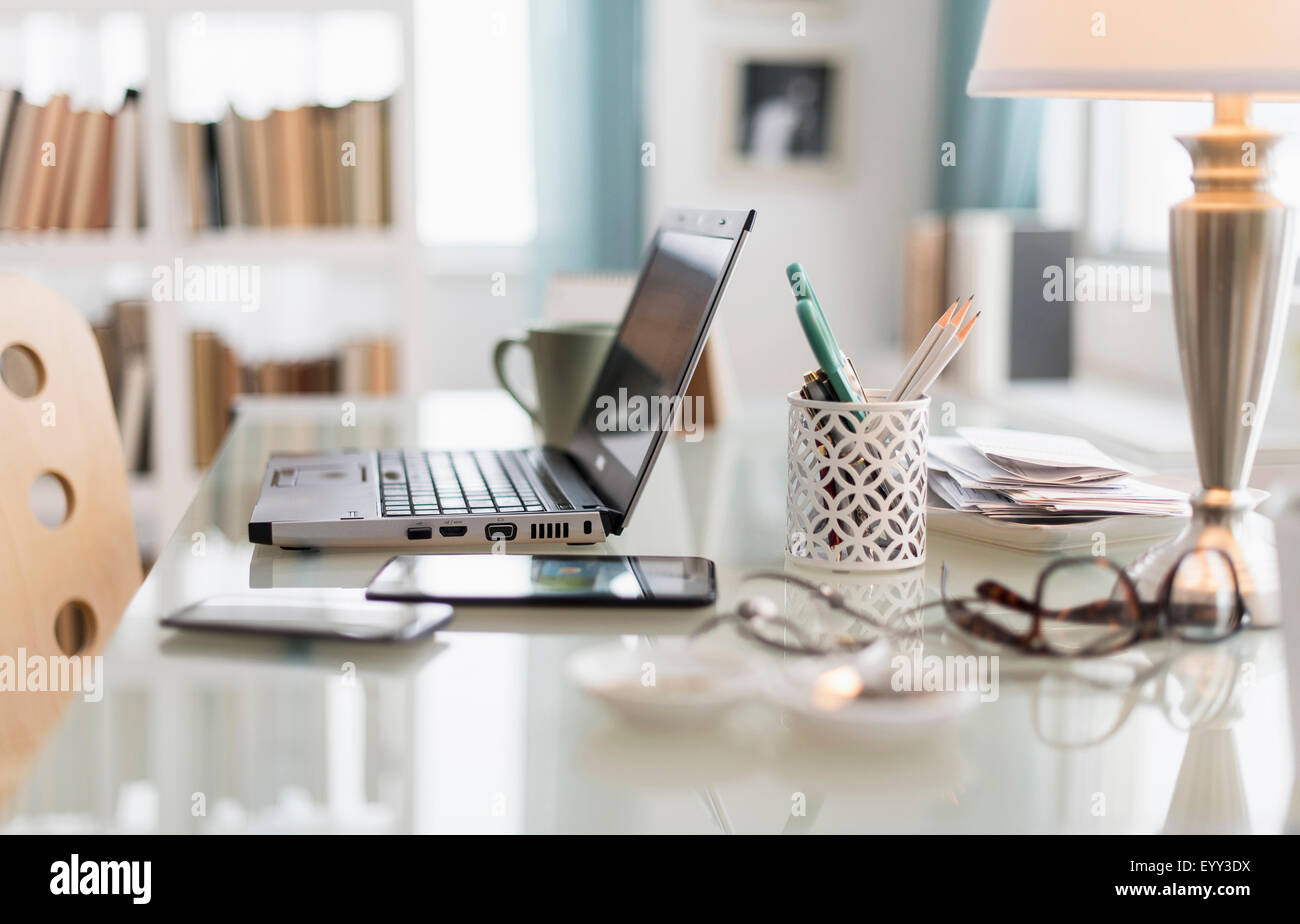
[935,548,1249,658]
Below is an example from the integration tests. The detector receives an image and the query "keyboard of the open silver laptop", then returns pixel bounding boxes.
[380,450,546,516]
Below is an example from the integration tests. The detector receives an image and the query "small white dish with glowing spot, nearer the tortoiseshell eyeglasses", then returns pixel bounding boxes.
[763,645,979,745]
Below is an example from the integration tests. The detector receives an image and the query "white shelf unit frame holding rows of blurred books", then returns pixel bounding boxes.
[0,0,429,561]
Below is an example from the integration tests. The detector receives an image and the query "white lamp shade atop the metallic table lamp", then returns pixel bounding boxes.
[966,0,1300,100]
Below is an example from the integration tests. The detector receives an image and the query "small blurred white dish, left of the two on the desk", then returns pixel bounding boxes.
[567,642,755,725]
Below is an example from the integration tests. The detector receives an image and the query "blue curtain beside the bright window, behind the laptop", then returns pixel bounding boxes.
[529,0,645,314]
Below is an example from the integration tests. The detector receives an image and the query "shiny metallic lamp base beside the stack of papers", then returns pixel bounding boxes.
[1131,94,1296,625]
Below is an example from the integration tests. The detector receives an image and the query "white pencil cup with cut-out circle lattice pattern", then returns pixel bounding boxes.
[785,389,930,571]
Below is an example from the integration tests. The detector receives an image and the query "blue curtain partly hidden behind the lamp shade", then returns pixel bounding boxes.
[936,0,1043,212]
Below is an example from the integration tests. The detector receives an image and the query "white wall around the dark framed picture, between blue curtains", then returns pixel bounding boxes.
[645,0,940,392]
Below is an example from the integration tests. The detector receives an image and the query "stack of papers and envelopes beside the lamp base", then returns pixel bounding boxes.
[928,426,1188,522]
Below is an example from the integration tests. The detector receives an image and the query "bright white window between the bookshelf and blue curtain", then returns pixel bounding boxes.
[415,0,537,246]
